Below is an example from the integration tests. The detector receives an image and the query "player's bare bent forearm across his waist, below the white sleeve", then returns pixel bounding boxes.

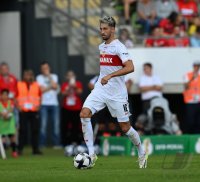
[101,60,134,85]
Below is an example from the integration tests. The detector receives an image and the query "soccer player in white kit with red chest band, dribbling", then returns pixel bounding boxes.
[80,16,148,168]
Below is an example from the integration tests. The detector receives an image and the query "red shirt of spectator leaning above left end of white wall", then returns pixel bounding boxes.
[145,38,168,47]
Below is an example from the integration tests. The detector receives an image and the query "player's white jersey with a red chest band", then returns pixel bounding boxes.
[95,39,131,100]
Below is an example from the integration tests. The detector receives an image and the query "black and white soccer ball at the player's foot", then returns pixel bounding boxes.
[74,153,91,169]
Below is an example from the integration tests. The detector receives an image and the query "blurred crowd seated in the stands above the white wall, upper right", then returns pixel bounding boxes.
[115,0,200,47]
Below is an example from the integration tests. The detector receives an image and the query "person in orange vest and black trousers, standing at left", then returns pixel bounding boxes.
[17,70,42,155]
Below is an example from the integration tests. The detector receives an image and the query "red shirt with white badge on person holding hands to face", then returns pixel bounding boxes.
[61,81,83,111]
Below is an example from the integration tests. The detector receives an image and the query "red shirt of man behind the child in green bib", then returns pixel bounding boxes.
[0,74,17,99]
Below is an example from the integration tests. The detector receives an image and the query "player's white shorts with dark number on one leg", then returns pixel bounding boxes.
[83,92,131,122]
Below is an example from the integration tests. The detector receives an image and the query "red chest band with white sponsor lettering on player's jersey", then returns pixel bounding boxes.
[100,54,123,66]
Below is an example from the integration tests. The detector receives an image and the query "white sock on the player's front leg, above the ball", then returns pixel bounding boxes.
[81,118,94,155]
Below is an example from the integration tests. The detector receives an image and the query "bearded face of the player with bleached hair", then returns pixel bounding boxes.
[100,23,115,41]
